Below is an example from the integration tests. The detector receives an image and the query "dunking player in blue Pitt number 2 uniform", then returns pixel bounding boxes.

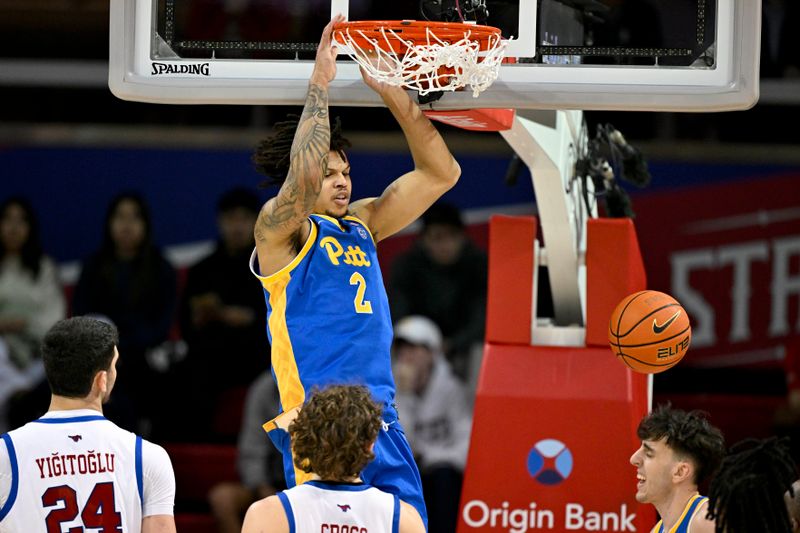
[251,16,461,519]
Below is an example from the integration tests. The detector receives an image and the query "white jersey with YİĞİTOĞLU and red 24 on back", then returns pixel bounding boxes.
[0,410,143,533]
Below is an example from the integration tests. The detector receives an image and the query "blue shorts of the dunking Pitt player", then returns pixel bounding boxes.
[268,418,428,531]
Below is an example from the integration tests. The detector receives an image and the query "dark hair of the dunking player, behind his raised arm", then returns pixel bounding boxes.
[251,114,351,187]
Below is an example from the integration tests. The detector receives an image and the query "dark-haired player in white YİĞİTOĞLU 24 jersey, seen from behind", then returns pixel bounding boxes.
[0,317,175,533]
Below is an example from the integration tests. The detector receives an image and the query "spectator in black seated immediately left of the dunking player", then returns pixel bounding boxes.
[170,188,268,439]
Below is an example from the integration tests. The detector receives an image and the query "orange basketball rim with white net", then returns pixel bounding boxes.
[333,20,508,97]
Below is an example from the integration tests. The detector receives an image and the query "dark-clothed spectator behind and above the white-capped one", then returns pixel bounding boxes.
[389,202,487,385]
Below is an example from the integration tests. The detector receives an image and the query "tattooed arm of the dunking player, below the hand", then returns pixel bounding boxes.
[256,84,331,236]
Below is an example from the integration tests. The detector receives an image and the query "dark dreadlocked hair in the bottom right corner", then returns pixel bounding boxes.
[708,437,797,533]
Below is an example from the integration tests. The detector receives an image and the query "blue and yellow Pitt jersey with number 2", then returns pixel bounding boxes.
[250,214,396,421]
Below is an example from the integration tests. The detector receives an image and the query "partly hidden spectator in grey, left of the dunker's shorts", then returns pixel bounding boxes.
[208,371,286,533]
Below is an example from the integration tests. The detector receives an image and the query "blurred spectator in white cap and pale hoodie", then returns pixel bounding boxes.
[392,316,472,532]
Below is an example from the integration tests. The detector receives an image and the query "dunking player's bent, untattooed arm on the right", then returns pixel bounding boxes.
[351,77,461,240]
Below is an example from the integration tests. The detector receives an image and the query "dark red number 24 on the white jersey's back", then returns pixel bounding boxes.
[42,481,122,533]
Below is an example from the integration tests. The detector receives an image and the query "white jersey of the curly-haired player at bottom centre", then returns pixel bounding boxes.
[278,481,400,533]
